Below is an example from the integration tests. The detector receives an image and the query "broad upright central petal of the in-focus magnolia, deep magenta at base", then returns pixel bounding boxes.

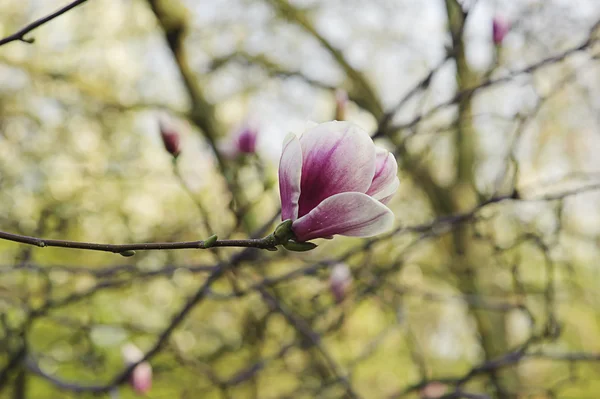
[298,121,375,217]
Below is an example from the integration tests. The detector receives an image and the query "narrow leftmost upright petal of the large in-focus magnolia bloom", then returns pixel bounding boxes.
[279,133,302,220]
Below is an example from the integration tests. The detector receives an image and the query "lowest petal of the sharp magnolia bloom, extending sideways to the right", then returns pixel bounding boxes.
[292,192,394,241]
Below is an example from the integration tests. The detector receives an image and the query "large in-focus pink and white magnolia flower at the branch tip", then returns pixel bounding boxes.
[279,121,399,242]
